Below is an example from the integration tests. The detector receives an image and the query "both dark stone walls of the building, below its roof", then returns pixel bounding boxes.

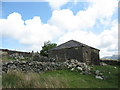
[49,46,100,65]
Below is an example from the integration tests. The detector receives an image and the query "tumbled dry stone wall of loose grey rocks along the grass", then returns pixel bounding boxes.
[2,59,105,79]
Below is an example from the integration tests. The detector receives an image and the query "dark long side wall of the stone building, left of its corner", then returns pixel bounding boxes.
[49,47,83,62]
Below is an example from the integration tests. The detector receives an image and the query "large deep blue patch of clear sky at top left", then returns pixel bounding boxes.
[2,2,52,23]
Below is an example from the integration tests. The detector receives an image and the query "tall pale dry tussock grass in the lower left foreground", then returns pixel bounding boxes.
[2,71,67,88]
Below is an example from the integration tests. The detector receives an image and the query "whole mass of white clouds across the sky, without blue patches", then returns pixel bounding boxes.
[0,0,118,56]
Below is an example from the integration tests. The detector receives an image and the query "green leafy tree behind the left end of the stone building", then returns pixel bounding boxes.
[40,41,57,57]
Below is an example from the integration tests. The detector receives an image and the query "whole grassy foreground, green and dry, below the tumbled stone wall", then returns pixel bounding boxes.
[2,66,118,88]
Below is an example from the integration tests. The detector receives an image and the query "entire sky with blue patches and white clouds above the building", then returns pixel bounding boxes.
[0,0,118,57]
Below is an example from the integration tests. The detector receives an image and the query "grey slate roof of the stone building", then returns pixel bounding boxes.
[51,40,99,50]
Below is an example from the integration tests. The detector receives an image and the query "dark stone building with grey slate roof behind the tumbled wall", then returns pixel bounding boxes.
[48,40,100,65]
